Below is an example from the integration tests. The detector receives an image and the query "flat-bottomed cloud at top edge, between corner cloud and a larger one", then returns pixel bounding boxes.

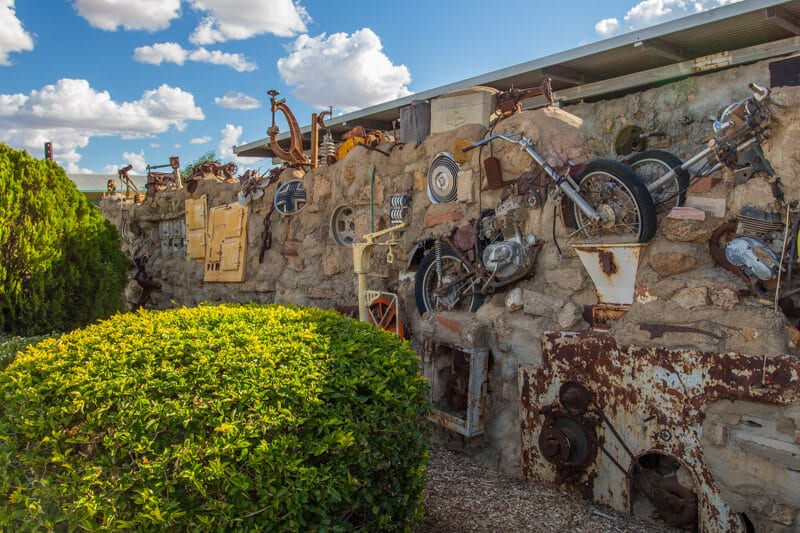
[74,0,181,31]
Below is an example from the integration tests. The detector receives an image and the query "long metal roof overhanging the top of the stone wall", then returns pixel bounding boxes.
[234,0,800,157]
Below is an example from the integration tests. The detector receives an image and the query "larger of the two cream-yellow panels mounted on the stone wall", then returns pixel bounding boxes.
[203,202,247,282]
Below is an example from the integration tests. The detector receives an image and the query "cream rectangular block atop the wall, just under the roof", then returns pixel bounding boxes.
[431,88,494,133]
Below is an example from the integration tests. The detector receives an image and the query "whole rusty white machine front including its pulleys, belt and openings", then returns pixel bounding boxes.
[519,332,800,532]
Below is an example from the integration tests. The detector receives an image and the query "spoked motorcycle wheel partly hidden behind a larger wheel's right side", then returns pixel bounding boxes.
[628,150,689,208]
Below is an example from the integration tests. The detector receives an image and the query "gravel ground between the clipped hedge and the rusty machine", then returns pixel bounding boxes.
[414,446,679,533]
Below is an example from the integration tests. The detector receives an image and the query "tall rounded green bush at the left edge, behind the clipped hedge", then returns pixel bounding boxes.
[0,144,127,335]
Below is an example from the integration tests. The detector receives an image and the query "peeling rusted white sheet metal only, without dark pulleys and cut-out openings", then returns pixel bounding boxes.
[520,332,800,531]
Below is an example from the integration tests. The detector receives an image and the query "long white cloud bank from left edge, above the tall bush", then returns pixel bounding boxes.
[0,78,205,169]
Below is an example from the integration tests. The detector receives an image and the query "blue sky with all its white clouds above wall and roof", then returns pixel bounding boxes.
[0,0,735,173]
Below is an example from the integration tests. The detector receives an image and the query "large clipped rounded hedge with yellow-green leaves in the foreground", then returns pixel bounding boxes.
[0,305,428,532]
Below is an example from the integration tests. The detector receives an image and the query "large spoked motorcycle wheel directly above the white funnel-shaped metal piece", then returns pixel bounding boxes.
[572,159,656,242]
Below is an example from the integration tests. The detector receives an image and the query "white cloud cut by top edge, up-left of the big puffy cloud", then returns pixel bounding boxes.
[189,0,311,44]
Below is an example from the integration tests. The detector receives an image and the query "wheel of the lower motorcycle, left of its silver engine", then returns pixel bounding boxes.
[414,244,483,315]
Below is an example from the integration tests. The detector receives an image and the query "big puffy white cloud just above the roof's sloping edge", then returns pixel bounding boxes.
[278,28,411,112]
